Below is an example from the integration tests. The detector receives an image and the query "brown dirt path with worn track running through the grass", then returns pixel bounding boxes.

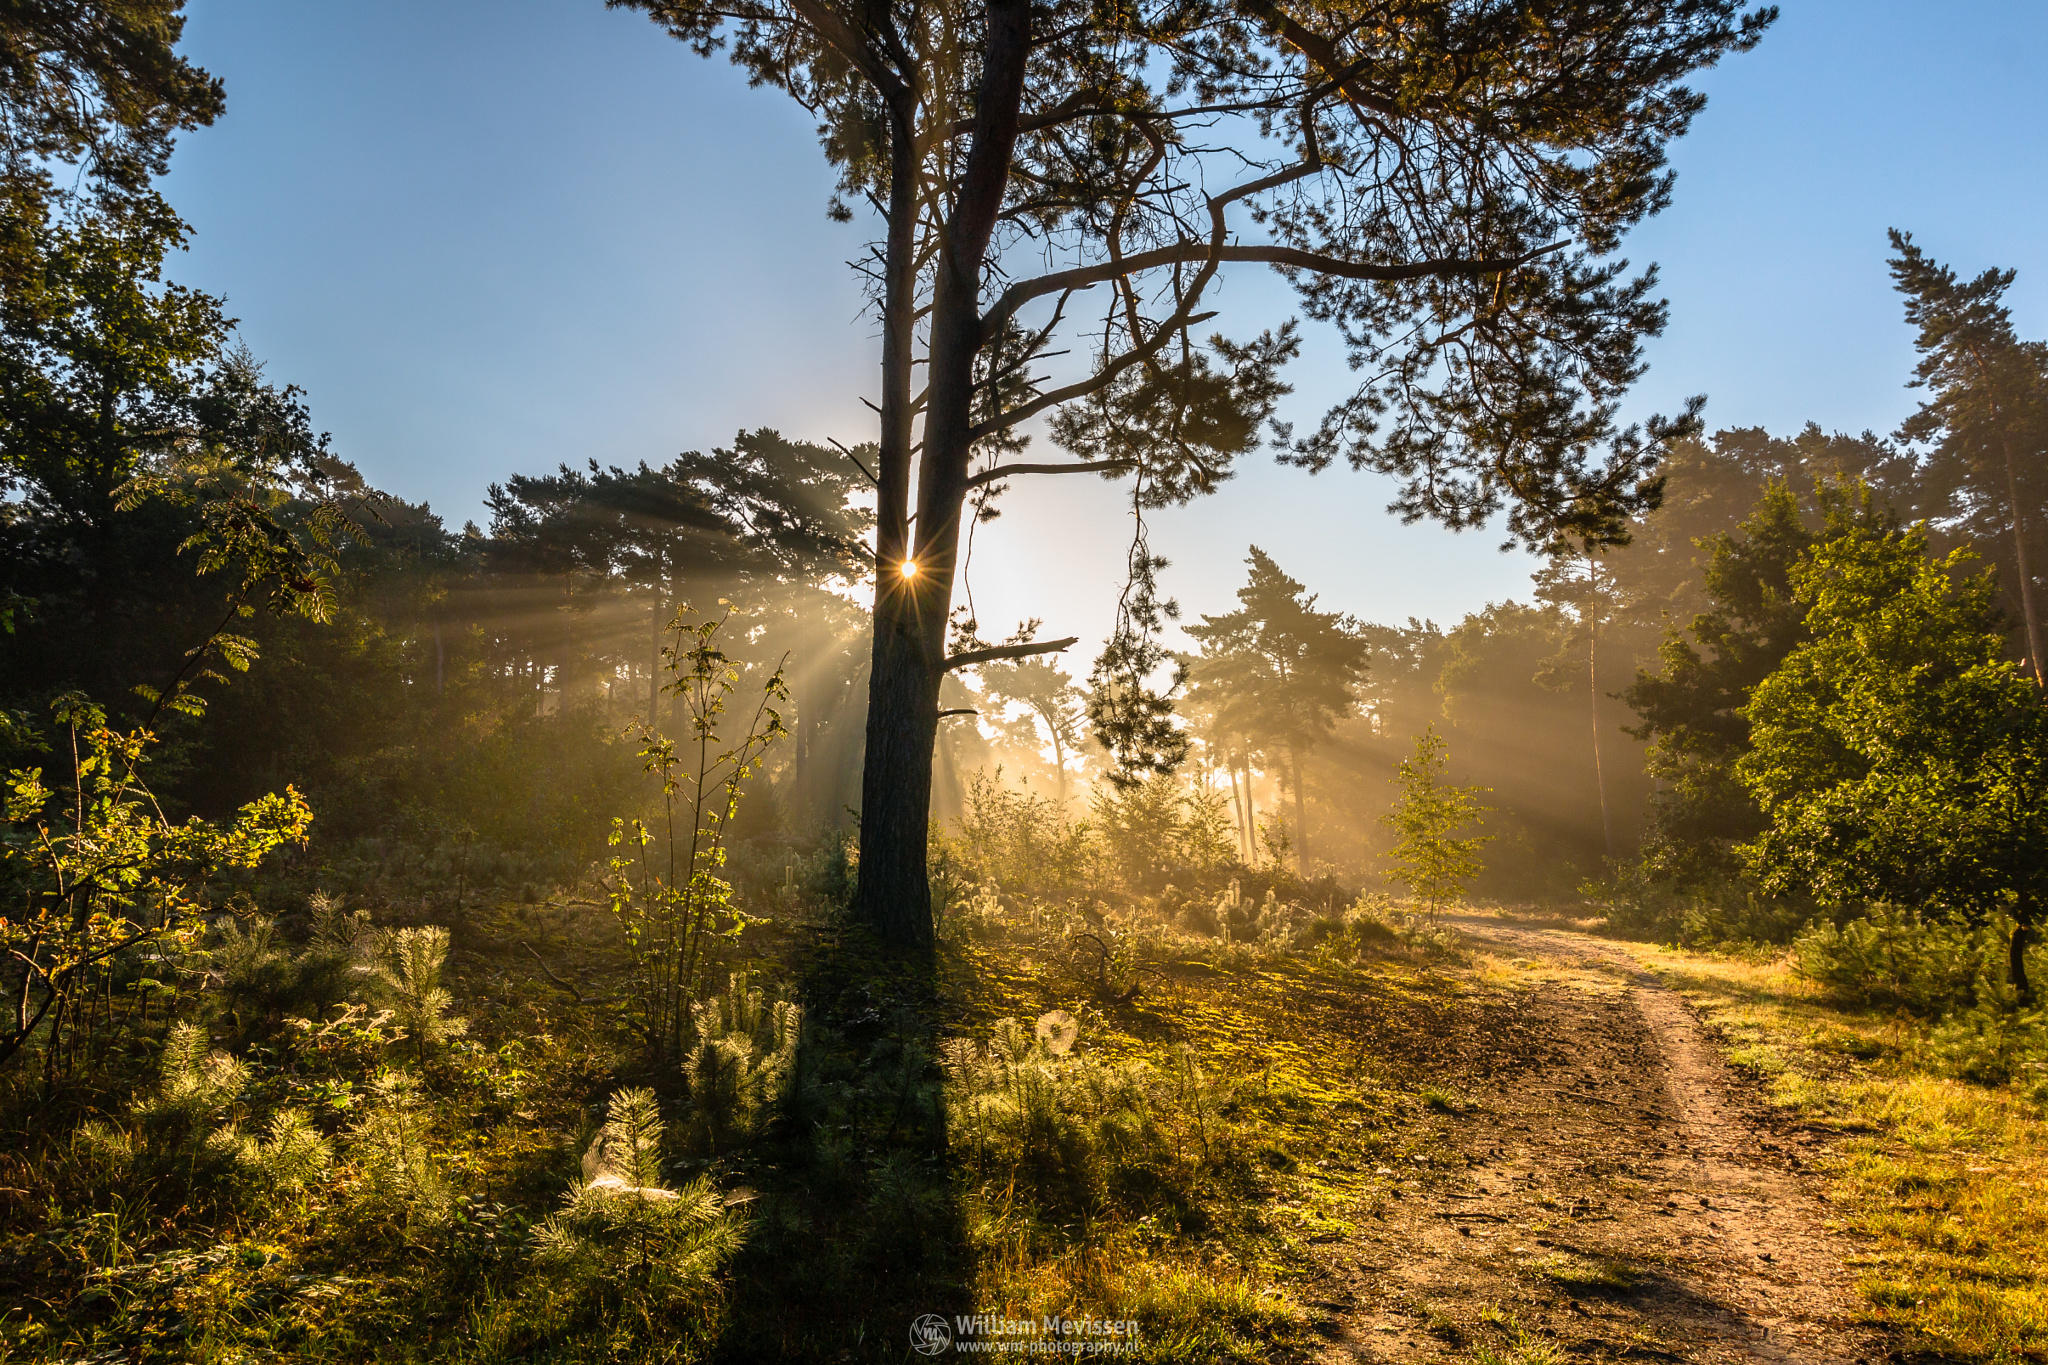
[1319,919,1884,1365]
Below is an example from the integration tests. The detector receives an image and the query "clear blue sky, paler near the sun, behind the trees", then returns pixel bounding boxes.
[168,0,2048,636]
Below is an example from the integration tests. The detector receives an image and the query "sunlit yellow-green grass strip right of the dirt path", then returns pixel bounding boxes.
[1628,945,2048,1363]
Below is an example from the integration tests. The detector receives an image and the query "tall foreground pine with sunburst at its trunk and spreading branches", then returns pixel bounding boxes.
[612,0,1776,945]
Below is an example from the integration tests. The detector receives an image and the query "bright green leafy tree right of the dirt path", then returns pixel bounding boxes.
[1735,526,2048,1005]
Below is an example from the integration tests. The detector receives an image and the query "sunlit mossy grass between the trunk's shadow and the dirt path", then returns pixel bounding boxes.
[946,935,1468,1361]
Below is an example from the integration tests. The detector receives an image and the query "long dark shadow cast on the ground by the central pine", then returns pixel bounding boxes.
[713,925,973,1363]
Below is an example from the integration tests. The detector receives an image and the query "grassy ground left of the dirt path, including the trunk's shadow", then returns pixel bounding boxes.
[0,888,1468,1363]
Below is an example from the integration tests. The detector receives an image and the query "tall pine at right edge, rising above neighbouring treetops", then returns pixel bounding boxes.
[1890,229,2048,686]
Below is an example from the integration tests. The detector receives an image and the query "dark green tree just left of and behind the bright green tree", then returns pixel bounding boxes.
[1624,483,1896,882]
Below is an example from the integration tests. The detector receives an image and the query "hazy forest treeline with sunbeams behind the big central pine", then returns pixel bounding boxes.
[12,246,2048,929]
